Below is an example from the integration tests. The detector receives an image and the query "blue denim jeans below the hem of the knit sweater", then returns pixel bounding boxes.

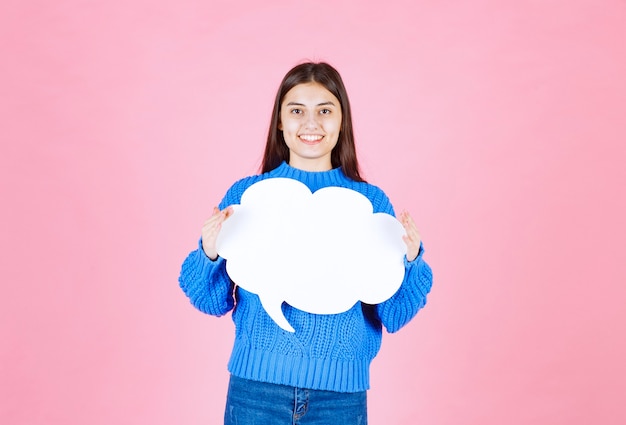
[224,375,367,425]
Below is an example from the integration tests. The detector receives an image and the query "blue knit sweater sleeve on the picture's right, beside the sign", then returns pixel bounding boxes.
[376,245,433,333]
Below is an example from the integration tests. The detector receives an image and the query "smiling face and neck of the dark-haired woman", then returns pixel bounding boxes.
[278,82,341,171]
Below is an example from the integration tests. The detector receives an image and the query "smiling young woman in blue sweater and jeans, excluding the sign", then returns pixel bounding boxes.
[179,63,432,425]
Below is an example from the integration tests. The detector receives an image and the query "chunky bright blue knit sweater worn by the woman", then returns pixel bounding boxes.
[179,162,432,392]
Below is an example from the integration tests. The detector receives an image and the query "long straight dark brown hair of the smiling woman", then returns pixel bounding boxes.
[261,62,365,182]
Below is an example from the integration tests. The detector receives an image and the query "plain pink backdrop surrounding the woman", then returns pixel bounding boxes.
[0,0,626,425]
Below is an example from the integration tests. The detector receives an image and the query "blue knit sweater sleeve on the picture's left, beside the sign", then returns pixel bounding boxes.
[178,240,234,316]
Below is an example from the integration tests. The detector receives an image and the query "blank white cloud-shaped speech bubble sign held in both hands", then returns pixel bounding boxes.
[217,178,406,332]
